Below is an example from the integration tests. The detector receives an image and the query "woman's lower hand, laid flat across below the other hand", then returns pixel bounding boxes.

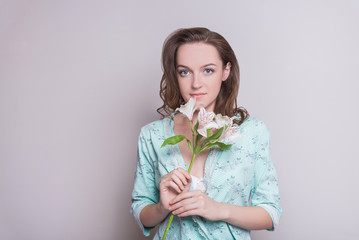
[169,190,221,221]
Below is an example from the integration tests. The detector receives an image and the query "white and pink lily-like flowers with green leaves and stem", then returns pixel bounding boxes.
[161,98,239,240]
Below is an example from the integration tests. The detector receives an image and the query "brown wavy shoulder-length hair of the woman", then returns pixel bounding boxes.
[157,28,249,125]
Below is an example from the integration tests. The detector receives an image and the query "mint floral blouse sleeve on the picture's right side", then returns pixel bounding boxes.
[251,124,282,231]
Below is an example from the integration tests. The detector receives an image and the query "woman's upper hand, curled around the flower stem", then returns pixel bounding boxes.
[159,168,191,211]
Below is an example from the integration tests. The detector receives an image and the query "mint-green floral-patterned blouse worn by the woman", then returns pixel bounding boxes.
[131,117,282,240]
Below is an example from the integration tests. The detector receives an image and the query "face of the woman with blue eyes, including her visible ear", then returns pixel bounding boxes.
[176,43,231,111]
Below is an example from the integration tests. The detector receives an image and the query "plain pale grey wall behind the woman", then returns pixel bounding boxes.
[0,0,359,240]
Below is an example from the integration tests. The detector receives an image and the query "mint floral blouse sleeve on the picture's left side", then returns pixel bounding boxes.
[131,129,159,236]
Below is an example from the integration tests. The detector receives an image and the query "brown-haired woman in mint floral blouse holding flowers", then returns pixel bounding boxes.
[131,28,281,239]
